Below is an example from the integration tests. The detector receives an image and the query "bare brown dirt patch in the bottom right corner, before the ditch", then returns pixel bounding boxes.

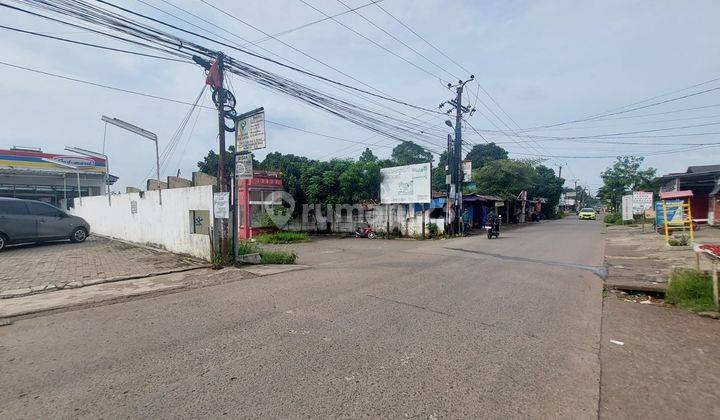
[600,295,720,419]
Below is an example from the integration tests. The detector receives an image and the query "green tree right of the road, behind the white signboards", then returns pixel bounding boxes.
[598,156,656,211]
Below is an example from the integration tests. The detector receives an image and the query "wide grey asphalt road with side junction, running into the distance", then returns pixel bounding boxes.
[0,219,603,418]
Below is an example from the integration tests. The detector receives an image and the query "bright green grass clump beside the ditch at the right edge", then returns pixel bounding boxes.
[665,270,715,312]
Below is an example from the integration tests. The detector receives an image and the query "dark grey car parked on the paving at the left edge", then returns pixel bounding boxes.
[0,197,90,251]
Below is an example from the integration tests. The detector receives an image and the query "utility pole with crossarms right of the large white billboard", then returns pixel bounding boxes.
[440,75,475,233]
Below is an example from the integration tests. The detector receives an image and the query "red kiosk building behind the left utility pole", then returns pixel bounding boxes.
[235,171,283,239]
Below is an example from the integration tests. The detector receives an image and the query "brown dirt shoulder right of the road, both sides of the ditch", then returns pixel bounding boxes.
[599,227,720,419]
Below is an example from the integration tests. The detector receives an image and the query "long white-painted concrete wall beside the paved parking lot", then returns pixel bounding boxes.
[72,186,214,260]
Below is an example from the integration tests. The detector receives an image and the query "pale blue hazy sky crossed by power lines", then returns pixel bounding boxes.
[0,0,720,191]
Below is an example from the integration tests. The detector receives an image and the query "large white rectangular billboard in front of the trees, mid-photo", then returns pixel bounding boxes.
[380,163,432,204]
